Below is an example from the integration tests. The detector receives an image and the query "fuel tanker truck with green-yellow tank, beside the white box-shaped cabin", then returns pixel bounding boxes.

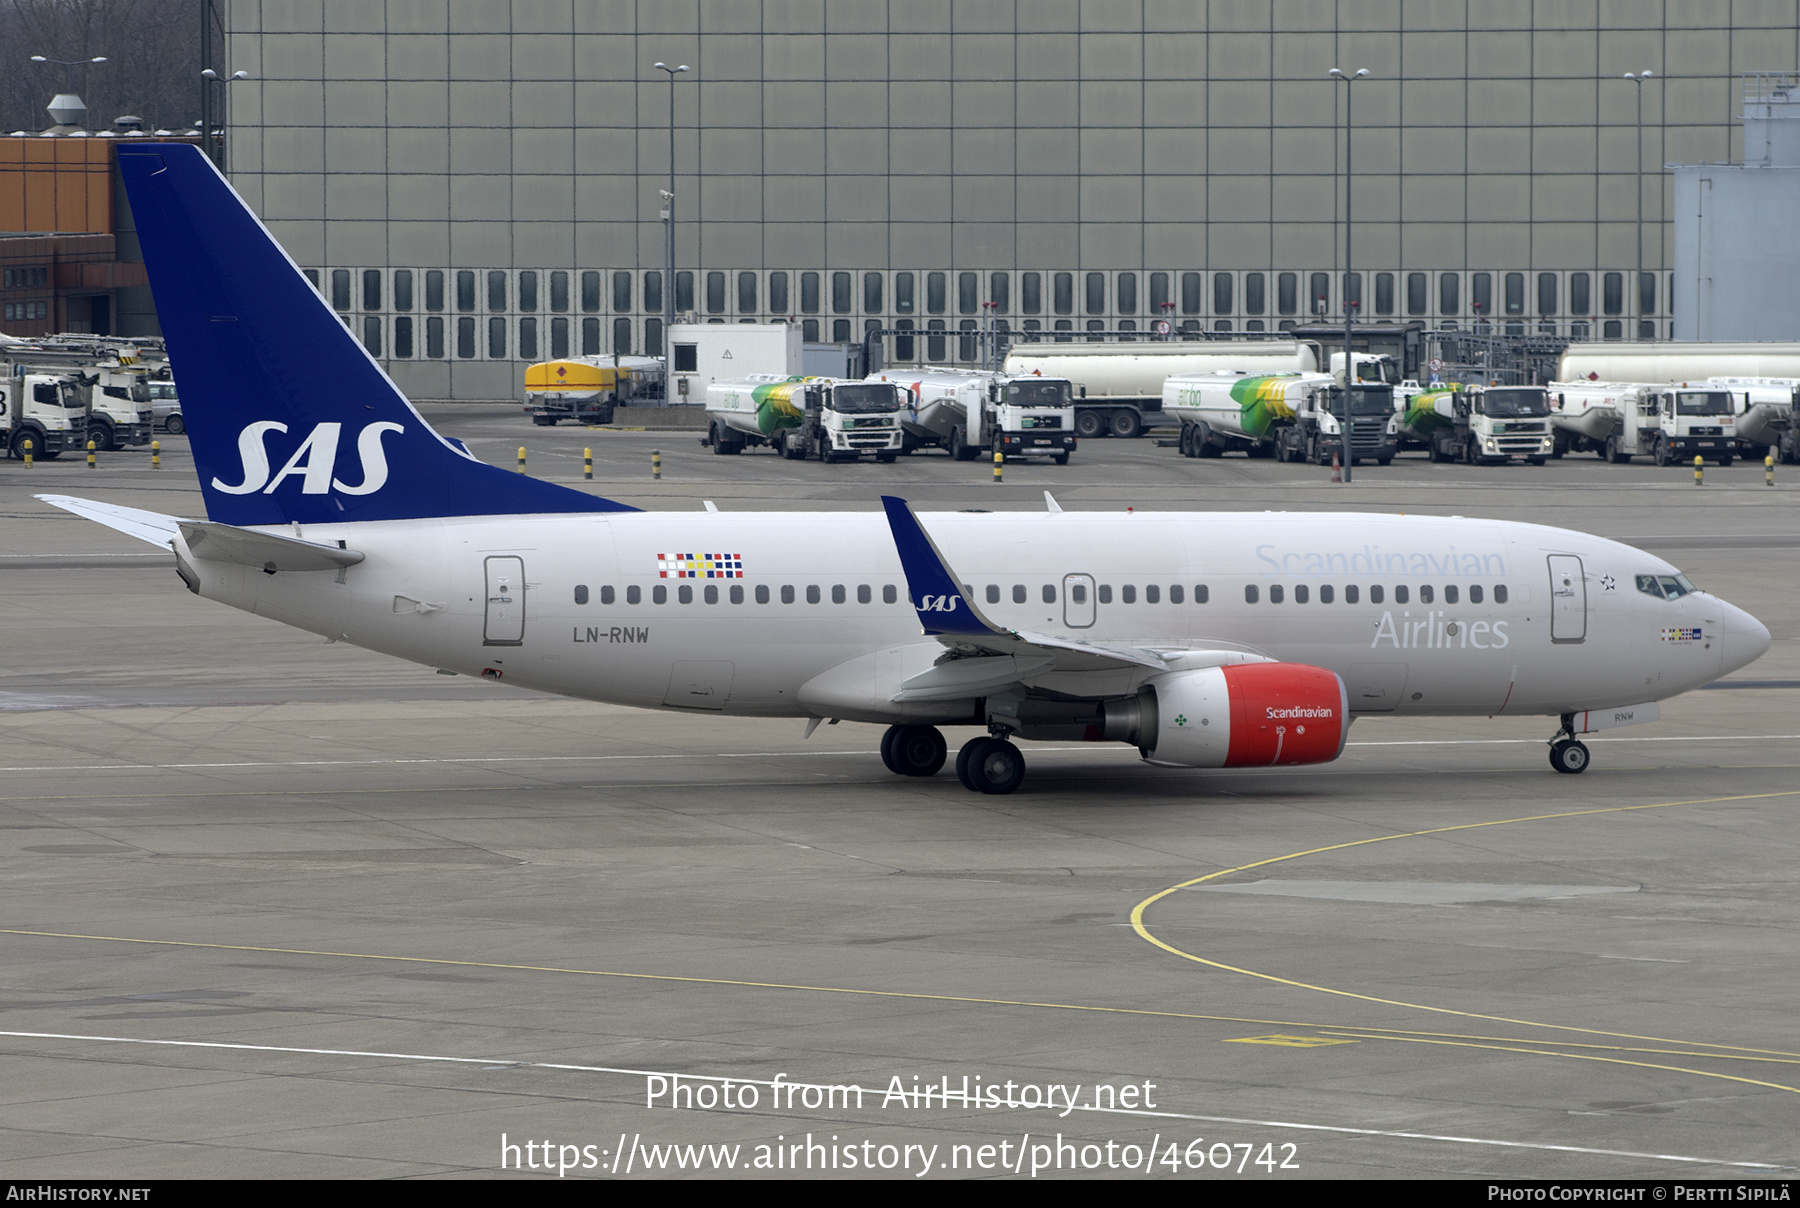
[702,374,909,461]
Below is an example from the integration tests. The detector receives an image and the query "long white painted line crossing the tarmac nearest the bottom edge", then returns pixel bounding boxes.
[0,1032,1787,1170]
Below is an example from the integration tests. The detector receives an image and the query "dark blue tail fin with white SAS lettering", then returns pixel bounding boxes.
[119,142,635,524]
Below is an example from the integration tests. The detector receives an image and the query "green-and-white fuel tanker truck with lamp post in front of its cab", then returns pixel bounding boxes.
[1163,373,1399,466]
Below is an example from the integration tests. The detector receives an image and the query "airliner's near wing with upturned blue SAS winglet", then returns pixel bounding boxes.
[882,495,1269,700]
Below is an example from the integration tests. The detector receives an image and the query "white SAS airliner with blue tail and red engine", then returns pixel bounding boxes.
[43,144,1769,792]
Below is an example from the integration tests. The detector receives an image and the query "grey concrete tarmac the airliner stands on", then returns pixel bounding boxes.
[0,417,1800,1181]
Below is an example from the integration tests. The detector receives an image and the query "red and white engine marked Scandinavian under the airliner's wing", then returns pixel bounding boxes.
[1105,663,1350,767]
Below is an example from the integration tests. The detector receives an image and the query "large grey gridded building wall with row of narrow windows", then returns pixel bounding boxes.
[227,0,1800,398]
